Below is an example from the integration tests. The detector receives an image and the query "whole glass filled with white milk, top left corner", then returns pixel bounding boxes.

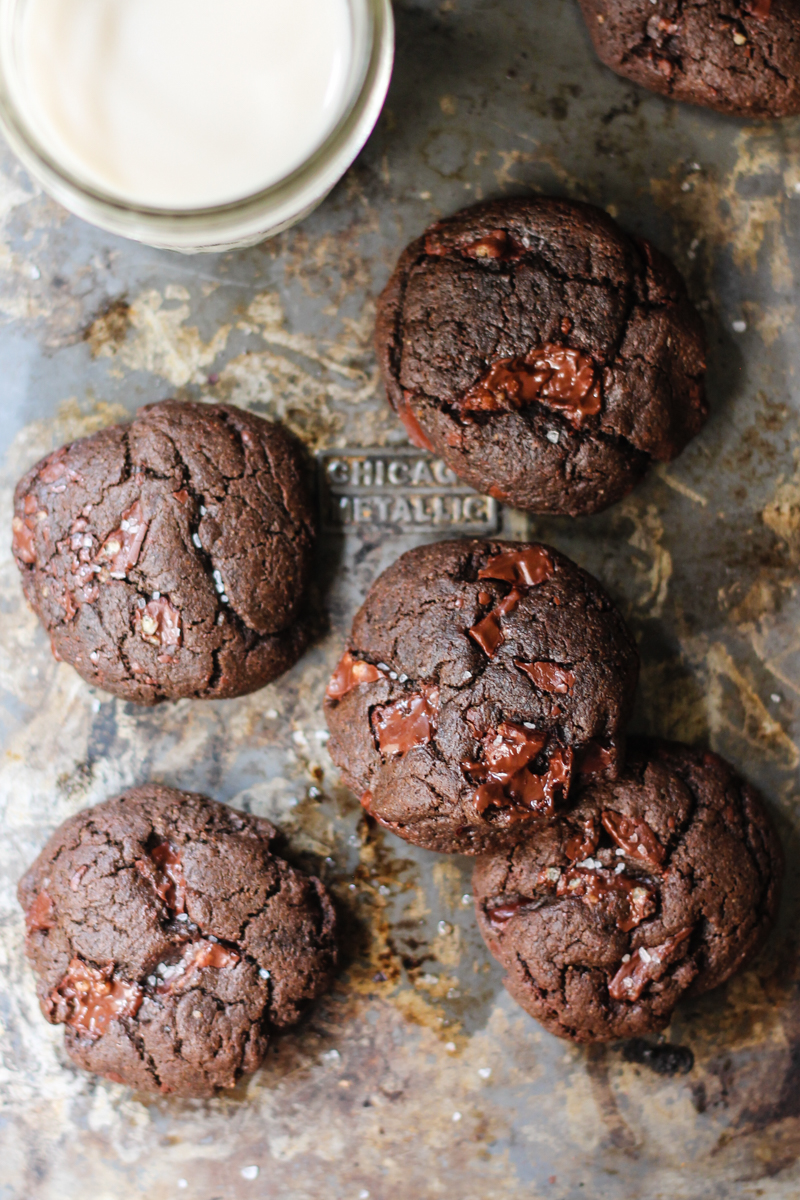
[0,0,395,251]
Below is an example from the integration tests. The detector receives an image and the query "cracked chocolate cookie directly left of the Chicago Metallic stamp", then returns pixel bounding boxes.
[13,400,314,704]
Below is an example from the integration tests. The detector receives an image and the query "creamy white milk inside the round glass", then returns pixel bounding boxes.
[16,0,353,210]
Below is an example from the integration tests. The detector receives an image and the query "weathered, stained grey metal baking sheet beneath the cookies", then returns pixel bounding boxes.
[0,0,800,1200]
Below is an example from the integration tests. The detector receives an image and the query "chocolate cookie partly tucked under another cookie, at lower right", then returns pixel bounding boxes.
[474,743,783,1042]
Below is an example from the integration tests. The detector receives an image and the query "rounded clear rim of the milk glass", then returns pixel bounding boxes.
[0,0,393,228]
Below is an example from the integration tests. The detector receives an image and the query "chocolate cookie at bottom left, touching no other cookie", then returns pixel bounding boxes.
[18,785,336,1096]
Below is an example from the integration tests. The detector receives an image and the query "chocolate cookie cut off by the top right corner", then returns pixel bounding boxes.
[581,0,800,118]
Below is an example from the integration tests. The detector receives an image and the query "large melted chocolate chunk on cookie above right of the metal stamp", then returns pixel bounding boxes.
[458,344,602,427]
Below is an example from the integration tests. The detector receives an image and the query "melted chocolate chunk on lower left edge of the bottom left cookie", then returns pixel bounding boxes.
[47,958,143,1039]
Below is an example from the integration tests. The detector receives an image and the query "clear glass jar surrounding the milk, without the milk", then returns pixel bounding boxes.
[0,0,395,253]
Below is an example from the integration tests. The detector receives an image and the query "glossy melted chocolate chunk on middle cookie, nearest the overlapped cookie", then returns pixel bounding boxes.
[462,721,572,820]
